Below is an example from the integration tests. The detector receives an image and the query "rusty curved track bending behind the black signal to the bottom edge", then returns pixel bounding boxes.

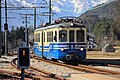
[12,58,68,80]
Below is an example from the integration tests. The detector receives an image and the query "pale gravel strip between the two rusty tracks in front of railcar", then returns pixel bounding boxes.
[31,59,84,77]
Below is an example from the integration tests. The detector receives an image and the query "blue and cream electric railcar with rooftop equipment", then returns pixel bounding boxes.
[34,18,86,61]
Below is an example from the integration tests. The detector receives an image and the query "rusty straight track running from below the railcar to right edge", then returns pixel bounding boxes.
[33,54,120,75]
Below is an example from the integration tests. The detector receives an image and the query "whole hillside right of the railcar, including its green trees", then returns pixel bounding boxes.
[79,0,120,47]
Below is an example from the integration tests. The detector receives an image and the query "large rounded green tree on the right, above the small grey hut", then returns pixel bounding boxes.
[94,18,120,48]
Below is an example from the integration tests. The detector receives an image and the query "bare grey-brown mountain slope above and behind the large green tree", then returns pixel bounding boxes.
[79,0,120,32]
